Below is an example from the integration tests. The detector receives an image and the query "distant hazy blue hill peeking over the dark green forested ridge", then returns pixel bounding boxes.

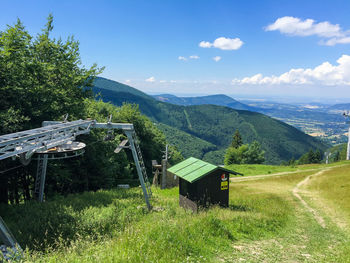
[153,94,256,111]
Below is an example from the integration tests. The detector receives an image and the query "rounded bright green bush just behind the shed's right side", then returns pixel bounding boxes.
[224,141,265,165]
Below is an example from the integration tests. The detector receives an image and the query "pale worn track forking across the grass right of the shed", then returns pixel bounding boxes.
[217,166,348,263]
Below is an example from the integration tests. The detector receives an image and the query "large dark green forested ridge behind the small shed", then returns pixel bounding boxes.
[93,78,326,164]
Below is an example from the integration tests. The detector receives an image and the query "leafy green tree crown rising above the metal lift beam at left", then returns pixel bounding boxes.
[0,15,101,134]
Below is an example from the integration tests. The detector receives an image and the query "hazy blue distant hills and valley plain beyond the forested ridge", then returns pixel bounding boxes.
[157,94,350,145]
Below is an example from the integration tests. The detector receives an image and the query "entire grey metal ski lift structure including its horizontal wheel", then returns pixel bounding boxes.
[0,116,152,257]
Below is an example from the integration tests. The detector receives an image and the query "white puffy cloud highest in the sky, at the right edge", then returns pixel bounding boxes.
[265,16,350,46]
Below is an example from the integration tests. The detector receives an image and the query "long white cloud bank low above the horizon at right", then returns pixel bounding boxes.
[232,55,350,86]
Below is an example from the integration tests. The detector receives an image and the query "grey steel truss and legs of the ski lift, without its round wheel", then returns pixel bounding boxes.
[0,118,152,256]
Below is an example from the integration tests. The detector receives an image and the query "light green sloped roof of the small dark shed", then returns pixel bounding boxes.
[168,157,237,183]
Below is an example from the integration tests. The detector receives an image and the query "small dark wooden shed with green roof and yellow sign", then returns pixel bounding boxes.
[168,157,240,211]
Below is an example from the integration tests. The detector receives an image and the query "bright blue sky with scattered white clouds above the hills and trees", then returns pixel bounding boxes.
[0,0,350,101]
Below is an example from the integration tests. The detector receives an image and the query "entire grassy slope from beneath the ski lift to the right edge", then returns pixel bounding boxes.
[0,163,350,262]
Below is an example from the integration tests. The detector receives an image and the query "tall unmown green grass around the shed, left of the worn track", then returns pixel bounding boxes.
[0,187,292,262]
